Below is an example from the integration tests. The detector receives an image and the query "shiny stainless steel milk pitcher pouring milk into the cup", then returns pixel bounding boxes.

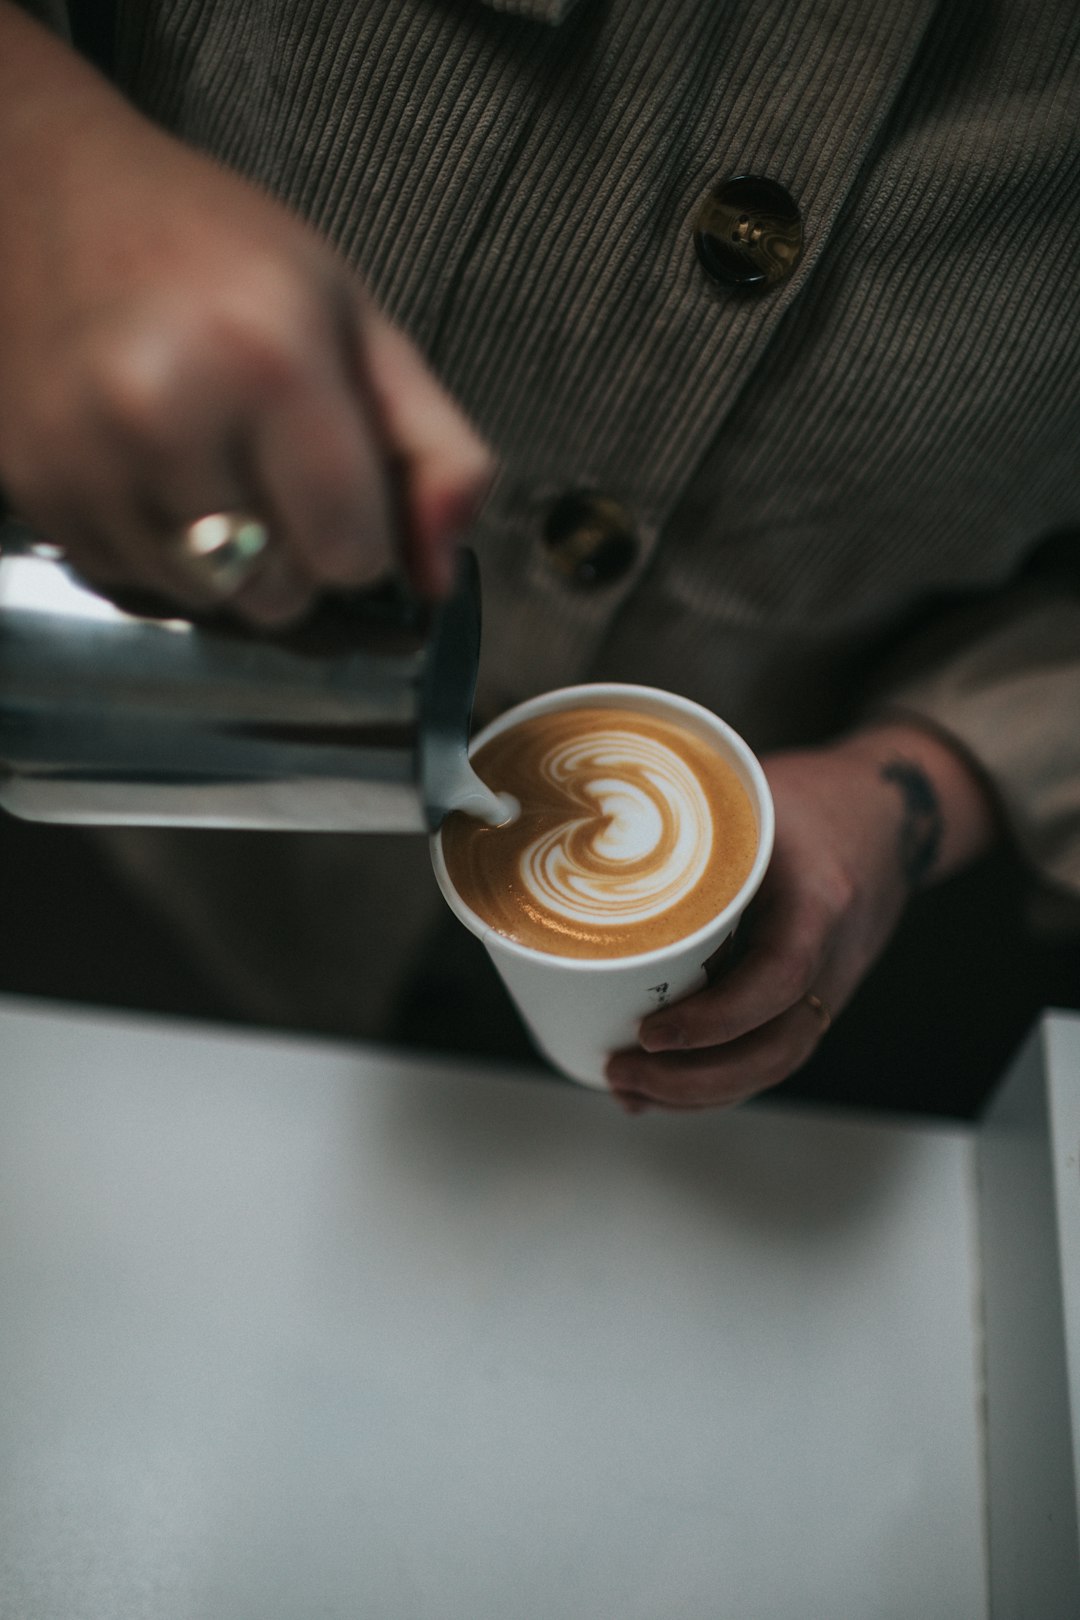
[0,525,483,831]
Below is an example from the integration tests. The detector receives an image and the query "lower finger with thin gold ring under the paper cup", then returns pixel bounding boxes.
[607,1003,824,1108]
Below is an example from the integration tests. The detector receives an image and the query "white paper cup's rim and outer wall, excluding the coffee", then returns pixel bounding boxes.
[431,682,772,1089]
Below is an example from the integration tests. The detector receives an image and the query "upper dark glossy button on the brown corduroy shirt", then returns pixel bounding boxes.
[693,175,803,288]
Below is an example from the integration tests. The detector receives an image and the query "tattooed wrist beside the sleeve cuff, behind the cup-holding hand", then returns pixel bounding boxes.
[836,718,999,889]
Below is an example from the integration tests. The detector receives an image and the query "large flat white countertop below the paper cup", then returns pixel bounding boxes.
[0,1003,986,1620]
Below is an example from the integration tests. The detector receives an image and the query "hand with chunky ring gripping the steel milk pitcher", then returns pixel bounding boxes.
[0,0,492,624]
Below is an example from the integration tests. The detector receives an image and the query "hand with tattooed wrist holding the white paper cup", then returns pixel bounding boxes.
[607,724,994,1113]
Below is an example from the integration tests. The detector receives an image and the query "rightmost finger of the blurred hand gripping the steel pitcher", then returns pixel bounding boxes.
[359,305,495,596]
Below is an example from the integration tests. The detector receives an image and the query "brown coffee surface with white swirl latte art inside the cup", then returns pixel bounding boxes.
[442,708,758,957]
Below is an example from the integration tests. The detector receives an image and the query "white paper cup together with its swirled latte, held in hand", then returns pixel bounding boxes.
[432,684,772,1087]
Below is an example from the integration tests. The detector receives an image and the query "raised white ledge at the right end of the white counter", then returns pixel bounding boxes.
[976,1013,1080,1620]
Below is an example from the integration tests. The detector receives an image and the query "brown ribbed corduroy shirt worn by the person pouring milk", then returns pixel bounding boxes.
[84,0,1080,888]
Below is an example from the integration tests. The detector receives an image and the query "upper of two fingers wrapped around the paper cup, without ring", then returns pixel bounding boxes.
[638,885,834,1051]
